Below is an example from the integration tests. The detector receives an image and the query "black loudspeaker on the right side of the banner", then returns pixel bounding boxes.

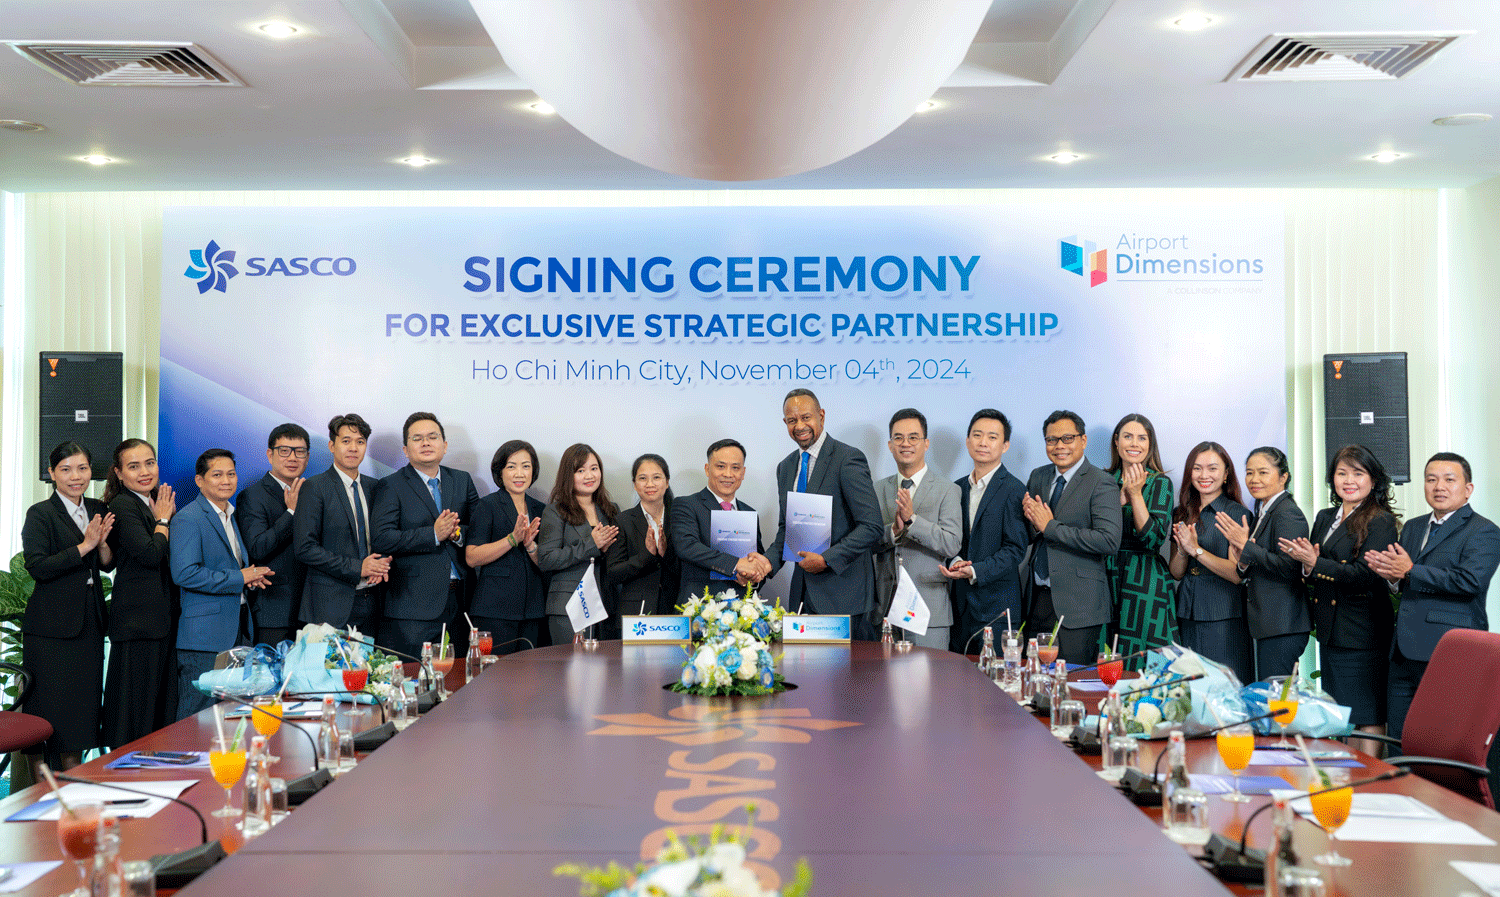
[1323,353,1412,483]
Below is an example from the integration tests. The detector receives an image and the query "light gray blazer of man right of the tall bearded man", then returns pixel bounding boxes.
[875,468,963,626]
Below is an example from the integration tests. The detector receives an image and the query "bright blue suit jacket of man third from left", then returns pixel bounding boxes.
[171,495,249,651]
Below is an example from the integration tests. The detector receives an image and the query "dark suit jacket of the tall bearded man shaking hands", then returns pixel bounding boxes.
[768,437,882,617]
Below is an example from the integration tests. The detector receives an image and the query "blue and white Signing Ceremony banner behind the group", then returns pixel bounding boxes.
[161,204,1286,576]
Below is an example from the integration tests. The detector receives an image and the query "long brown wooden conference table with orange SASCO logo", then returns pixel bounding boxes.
[0,642,1500,897]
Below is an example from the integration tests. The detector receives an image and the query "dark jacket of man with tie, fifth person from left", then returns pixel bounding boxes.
[293,467,384,627]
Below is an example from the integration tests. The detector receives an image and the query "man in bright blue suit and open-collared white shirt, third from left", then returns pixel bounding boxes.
[171,449,272,720]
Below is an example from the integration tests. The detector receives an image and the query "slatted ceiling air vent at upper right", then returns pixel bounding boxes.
[1226,32,1473,81]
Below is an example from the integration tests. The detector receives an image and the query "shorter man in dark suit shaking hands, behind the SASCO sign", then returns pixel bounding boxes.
[668,440,771,605]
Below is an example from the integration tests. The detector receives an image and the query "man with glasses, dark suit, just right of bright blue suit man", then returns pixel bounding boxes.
[234,423,311,645]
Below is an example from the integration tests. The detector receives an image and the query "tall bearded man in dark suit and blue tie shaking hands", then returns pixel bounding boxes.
[768,389,881,642]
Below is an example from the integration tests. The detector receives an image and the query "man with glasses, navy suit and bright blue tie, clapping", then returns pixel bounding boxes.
[372,411,479,656]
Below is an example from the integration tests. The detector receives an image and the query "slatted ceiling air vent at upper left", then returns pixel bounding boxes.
[8,41,245,87]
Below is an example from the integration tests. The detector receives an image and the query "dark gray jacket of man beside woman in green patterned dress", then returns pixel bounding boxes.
[1022,458,1124,629]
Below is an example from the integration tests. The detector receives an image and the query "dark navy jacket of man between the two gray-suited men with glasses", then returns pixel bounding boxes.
[954,464,1031,627]
